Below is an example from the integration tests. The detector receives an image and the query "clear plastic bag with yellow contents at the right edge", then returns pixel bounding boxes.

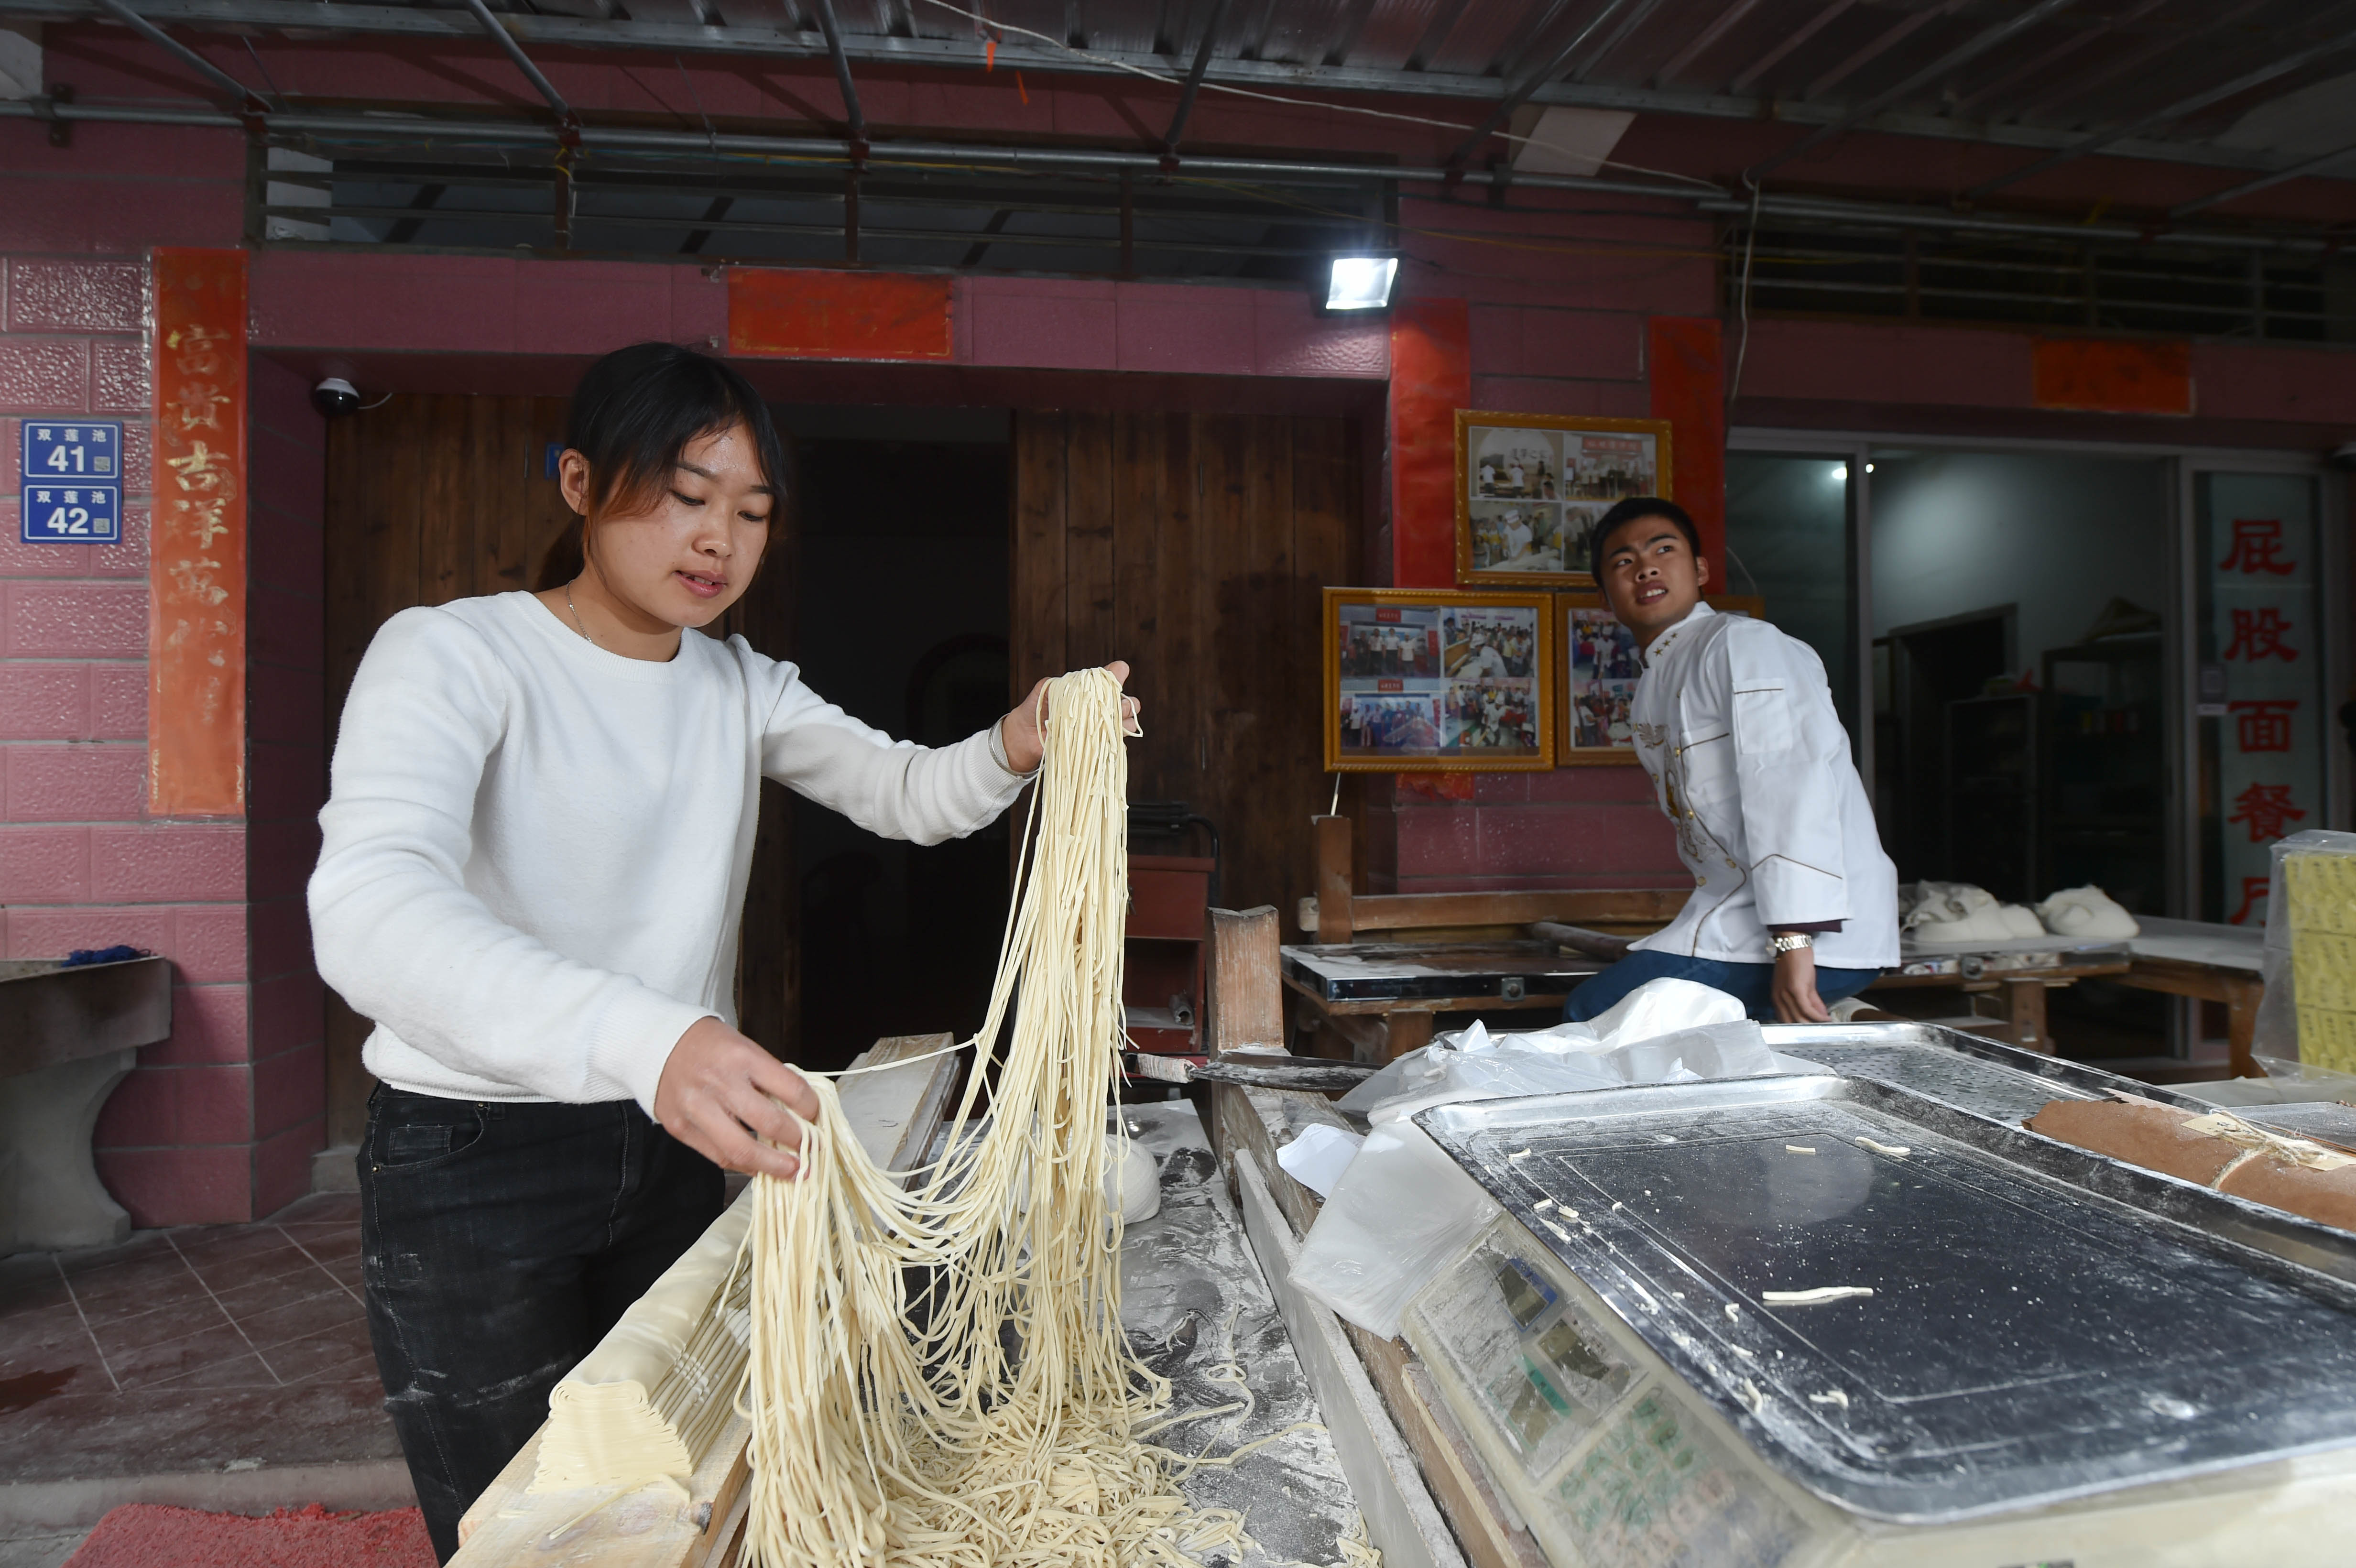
[2250,829,2356,1074]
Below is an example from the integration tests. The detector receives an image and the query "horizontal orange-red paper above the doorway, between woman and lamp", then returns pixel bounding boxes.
[728,266,954,360]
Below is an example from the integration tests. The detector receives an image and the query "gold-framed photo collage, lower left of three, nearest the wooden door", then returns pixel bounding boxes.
[1324,588,1557,772]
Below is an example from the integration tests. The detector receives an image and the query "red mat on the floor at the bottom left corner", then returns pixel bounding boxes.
[64,1502,434,1568]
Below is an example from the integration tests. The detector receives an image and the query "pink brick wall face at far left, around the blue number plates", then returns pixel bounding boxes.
[0,107,262,1224]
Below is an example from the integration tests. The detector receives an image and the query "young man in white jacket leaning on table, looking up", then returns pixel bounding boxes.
[1564,497,1899,1024]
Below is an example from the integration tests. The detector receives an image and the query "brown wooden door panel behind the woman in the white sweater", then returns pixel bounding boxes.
[325,393,794,1144]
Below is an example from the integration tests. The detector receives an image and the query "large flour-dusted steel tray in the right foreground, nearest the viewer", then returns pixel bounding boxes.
[1416,1068,2356,1523]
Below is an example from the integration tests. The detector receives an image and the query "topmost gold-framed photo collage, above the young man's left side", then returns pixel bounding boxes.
[1456,410,1670,588]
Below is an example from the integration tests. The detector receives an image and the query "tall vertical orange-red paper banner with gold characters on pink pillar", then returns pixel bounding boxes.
[148,250,245,817]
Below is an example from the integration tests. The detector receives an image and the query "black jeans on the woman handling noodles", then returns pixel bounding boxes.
[360,1085,726,1561]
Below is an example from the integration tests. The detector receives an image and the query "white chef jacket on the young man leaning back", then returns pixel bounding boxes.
[1630,605,1899,970]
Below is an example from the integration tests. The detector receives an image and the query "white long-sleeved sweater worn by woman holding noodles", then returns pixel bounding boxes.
[311,593,1023,1113]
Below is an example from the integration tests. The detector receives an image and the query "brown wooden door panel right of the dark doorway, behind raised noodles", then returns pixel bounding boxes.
[1011,412,1359,921]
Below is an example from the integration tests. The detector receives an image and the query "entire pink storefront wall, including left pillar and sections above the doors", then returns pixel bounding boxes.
[0,23,2356,1224]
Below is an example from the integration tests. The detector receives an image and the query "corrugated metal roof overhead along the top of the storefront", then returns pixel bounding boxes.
[0,0,2356,199]
